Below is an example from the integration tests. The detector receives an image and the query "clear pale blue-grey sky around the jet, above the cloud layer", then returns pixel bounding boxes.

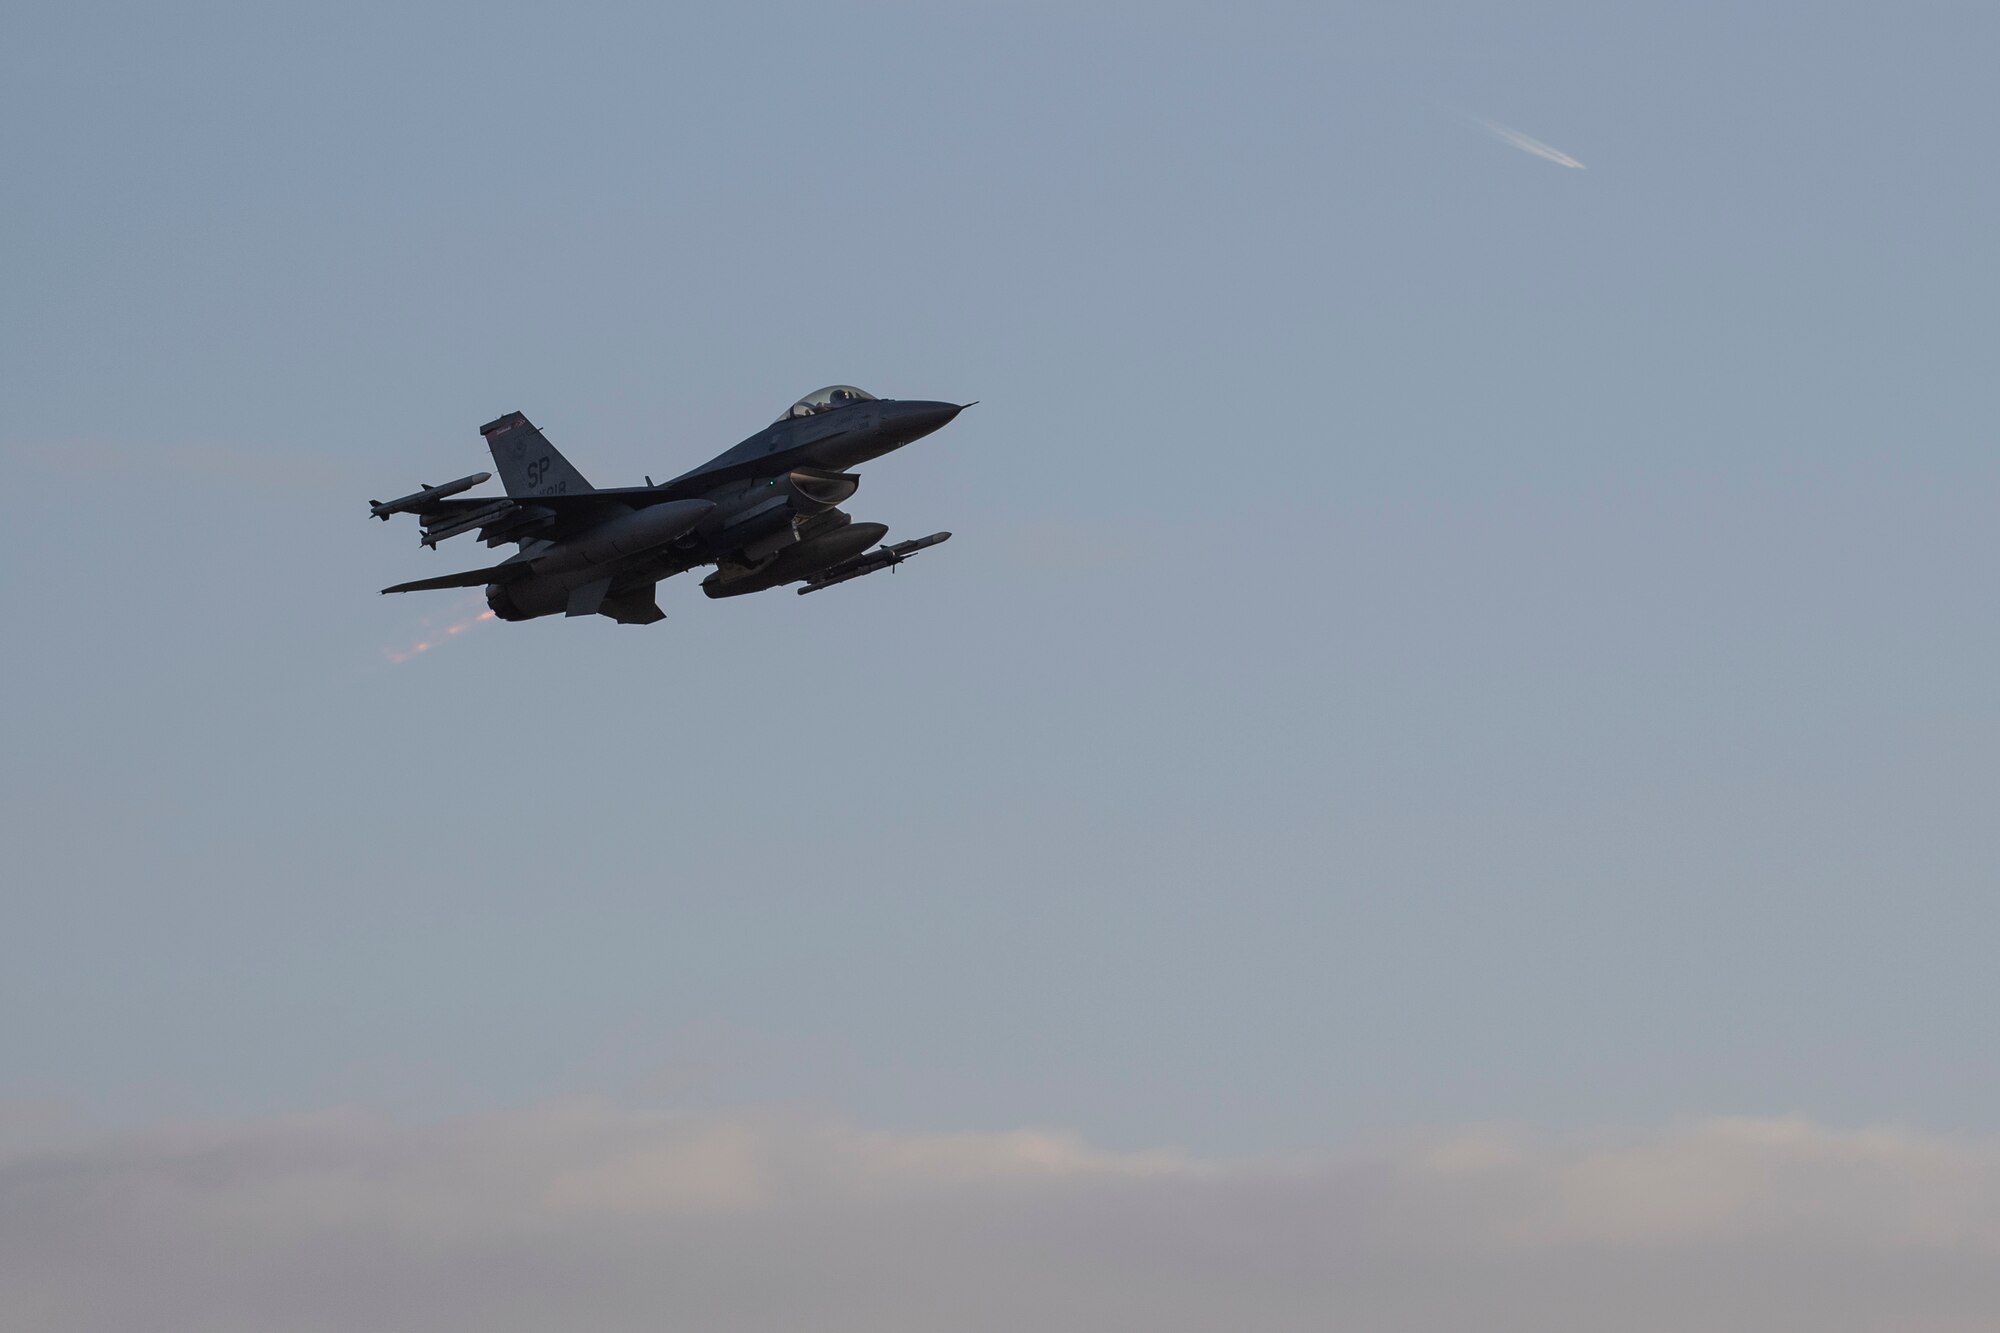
[0,4,2000,1153]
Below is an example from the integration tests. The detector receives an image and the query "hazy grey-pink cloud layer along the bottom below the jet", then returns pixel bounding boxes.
[0,1103,2000,1333]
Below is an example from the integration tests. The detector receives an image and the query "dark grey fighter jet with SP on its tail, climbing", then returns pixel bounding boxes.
[370,384,972,624]
